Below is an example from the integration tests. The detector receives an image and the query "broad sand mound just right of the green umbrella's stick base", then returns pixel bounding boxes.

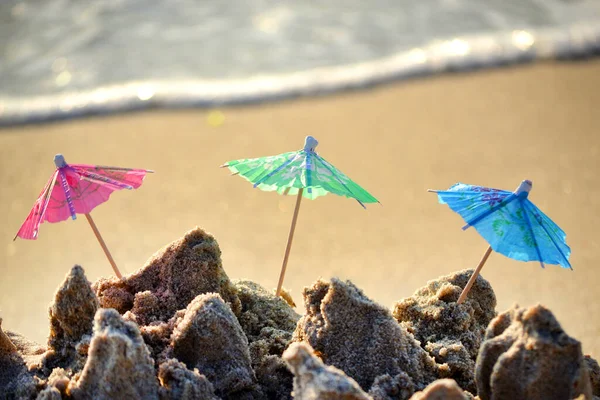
[294,278,439,390]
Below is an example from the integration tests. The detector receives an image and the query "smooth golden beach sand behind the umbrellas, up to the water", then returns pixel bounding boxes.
[0,60,600,357]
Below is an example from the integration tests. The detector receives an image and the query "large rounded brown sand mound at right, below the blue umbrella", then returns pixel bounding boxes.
[476,305,592,400]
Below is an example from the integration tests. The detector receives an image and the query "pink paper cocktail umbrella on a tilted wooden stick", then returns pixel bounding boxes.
[14,154,154,278]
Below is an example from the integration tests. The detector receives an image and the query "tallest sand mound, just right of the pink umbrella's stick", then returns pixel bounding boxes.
[94,228,240,325]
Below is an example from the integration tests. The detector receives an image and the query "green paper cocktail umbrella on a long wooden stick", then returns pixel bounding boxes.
[221,136,379,296]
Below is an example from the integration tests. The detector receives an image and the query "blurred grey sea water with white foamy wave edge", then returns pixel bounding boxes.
[0,0,600,123]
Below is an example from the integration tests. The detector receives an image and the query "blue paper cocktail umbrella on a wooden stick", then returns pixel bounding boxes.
[429,180,573,304]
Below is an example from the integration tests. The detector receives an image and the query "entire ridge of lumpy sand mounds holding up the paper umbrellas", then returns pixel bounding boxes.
[0,228,600,400]
